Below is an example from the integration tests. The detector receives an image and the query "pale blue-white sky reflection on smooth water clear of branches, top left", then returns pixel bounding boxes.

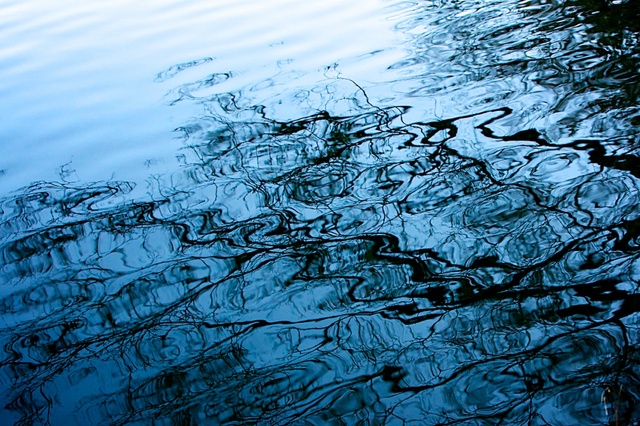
[0,0,394,192]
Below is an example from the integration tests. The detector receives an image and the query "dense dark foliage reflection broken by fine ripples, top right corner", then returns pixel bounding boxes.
[393,0,640,163]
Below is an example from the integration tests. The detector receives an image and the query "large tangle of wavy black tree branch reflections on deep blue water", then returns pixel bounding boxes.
[0,2,640,425]
